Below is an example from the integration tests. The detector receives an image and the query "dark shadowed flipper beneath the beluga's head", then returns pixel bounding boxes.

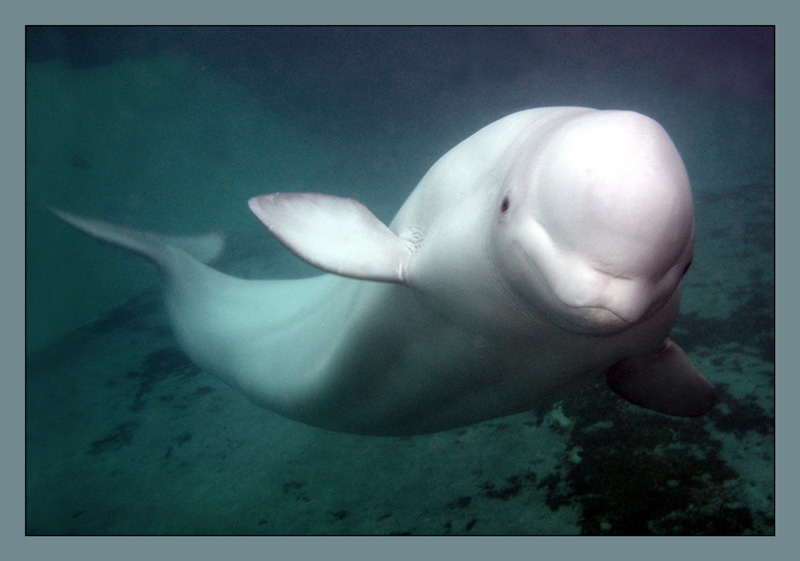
[606,339,714,417]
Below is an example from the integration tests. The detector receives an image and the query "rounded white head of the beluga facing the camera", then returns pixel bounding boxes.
[490,111,694,334]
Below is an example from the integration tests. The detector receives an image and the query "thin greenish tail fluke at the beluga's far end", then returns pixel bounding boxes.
[50,207,225,268]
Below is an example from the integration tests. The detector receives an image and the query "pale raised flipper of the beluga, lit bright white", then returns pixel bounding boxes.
[248,193,413,284]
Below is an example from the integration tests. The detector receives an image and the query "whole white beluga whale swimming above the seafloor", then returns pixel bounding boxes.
[53,107,714,435]
